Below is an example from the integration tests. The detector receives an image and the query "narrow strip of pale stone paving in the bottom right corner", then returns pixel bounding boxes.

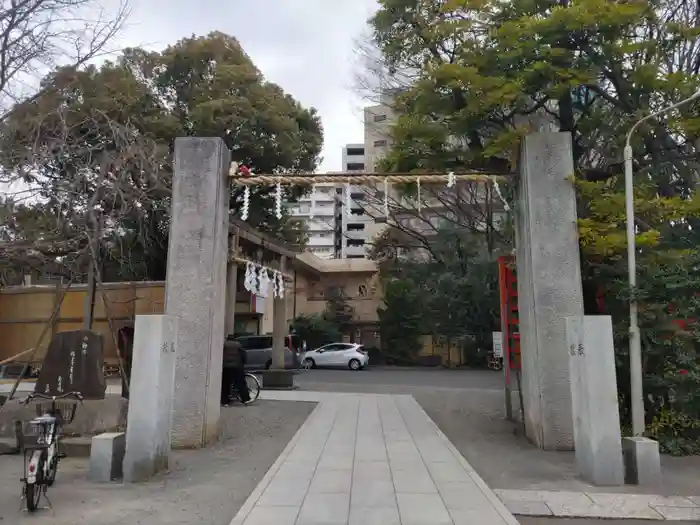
[495,490,700,522]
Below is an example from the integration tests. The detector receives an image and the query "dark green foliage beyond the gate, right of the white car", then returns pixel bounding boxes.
[379,227,499,360]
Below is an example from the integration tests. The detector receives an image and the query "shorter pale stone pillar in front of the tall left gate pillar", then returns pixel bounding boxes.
[124,315,178,483]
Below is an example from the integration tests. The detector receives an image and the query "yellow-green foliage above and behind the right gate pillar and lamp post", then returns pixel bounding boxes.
[371,0,700,454]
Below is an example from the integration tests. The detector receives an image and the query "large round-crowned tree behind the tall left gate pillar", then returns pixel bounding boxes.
[0,33,322,280]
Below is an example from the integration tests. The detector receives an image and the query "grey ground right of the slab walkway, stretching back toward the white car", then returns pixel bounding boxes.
[298,367,700,496]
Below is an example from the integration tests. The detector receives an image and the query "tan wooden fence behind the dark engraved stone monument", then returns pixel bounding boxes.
[0,281,165,363]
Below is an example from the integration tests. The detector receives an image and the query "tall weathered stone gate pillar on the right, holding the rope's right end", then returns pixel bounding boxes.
[516,132,583,450]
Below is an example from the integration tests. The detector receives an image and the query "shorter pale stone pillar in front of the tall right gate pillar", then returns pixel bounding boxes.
[566,315,625,485]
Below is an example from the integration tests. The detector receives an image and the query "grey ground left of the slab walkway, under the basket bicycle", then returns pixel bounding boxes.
[0,401,315,525]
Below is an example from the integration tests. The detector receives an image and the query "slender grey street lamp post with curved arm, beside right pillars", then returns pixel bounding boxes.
[624,91,700,436]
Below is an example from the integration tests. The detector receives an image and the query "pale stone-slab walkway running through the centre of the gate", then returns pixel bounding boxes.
[231,392,518,525]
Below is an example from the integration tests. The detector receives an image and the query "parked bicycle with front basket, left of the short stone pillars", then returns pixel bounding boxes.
[21,392,83,512]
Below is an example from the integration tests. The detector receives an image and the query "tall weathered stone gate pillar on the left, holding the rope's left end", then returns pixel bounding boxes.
[165,137,230,448]
